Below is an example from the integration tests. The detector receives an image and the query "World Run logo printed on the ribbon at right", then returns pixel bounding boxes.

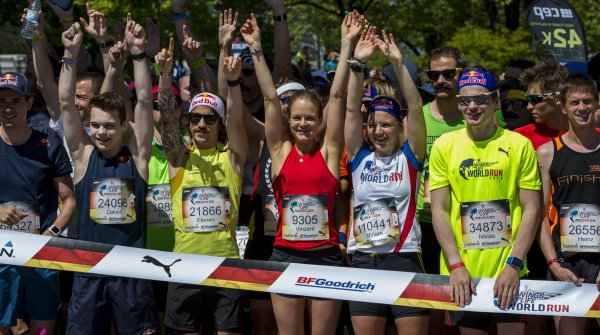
[494,285,571,313]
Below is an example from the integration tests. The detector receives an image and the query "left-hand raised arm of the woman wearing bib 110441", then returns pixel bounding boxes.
[344,25,377,161]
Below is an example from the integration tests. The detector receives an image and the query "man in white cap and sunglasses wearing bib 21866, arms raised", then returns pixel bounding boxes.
[159,51,248,334]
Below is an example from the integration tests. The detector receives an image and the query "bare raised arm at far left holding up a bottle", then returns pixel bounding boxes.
[26,9,60,122]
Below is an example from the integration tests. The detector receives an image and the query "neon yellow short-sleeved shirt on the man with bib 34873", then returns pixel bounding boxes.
[429,127,541,278]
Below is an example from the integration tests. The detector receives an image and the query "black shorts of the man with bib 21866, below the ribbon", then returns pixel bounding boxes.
[165,283,243,334]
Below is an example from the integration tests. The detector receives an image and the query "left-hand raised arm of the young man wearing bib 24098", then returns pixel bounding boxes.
[58,23,92,161]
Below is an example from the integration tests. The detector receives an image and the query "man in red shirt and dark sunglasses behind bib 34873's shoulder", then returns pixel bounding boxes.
[515,63,569,150]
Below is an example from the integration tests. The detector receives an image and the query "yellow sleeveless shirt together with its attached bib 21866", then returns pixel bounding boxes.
[171,144,242,258]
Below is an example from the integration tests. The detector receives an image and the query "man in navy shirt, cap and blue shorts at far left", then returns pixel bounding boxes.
[0,72,75,334]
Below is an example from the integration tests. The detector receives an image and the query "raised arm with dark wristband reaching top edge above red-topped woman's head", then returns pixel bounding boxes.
[265,0,293,82]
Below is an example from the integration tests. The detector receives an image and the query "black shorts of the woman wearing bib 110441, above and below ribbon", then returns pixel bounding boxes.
[349,252,429,319]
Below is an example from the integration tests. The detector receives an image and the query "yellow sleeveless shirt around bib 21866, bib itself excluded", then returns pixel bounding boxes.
[171,144,242,258]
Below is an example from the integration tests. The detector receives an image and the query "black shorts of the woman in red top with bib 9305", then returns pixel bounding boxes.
[270,246,344,300]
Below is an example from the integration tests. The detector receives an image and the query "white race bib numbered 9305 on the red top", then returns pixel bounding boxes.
[281,194,329,241]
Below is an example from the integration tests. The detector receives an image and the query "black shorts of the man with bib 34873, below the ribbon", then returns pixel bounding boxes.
[446,311,525,332]
